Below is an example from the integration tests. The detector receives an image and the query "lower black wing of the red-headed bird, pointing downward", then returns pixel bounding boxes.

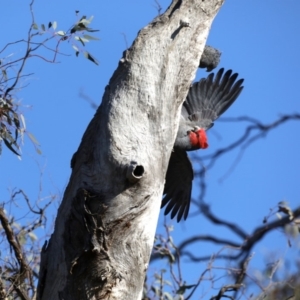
[161,149,194,222]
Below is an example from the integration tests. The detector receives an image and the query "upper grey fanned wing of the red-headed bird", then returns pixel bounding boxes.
[181,68,244,129]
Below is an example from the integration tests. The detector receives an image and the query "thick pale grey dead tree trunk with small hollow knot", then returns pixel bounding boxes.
[38,0,224,300]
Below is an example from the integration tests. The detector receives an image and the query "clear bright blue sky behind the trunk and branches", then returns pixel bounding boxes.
[0,0,300,299]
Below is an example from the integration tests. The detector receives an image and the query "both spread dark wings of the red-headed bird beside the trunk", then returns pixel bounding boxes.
[161,69,244,222]
